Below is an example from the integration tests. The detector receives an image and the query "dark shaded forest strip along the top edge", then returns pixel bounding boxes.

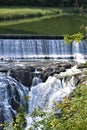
[0,0,87,7]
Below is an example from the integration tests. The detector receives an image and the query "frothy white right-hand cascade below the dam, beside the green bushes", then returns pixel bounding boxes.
[25,67,81,130]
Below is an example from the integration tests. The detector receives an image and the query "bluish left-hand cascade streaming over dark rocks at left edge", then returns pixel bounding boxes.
[0,73,28,126]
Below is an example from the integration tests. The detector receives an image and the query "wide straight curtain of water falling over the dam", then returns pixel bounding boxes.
[0,39,87,60]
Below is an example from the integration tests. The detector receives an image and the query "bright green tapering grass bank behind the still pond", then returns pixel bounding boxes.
[0,7,62,21]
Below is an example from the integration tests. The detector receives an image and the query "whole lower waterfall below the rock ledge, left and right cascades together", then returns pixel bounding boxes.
[0,64,81,130]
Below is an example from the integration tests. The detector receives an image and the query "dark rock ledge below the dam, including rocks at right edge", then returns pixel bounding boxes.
[0,61,87,88]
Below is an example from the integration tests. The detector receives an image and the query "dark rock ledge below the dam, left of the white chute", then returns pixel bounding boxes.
[0,61,71,88]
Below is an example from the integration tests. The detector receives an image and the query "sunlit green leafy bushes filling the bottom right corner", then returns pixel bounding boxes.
[31,85,87,130]
